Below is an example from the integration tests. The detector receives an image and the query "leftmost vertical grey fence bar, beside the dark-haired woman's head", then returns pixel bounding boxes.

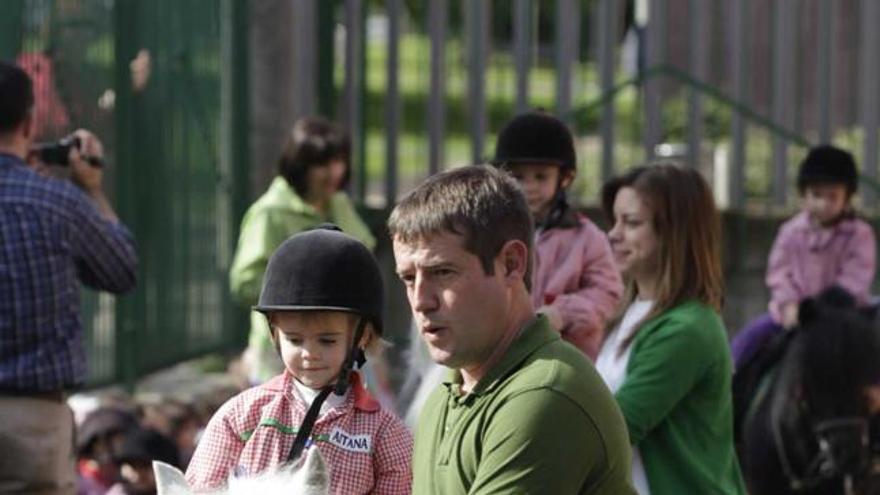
[345,0,364,200]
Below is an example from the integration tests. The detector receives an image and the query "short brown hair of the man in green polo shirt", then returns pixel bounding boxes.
[388,165,534,288]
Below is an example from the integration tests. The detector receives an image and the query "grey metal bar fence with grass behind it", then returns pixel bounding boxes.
[304,0,880,213]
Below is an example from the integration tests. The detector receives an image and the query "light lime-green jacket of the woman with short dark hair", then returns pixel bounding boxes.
[229,176,376,382]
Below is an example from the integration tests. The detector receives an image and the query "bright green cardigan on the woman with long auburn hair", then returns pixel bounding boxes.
[616,301,746,495]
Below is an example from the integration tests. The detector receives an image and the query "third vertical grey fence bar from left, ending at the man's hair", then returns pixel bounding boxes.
[428,0,447,175]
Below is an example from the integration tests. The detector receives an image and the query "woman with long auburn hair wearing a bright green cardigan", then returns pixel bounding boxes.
[596,163,745,495]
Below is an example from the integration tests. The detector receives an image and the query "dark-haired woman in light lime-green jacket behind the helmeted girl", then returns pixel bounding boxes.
[229,117,376,384]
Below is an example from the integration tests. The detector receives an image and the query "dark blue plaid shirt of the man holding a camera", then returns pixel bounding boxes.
[0,153,137,392]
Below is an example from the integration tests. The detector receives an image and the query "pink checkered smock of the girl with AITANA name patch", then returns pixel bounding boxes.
[186,372,412,495]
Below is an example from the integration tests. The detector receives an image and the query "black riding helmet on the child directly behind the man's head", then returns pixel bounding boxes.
[491,111,577,171]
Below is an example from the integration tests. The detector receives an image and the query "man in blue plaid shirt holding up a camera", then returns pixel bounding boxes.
[0,62,137,494]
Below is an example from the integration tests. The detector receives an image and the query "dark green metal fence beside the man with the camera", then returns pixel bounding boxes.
[0,0,248,386]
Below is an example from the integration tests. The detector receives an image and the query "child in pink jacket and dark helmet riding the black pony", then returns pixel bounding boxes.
[732,145,876,369]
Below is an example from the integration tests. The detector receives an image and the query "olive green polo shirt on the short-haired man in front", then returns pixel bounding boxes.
[413,316,636,495]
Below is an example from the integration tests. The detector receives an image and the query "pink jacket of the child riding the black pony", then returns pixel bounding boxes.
[767,212,877,323]
